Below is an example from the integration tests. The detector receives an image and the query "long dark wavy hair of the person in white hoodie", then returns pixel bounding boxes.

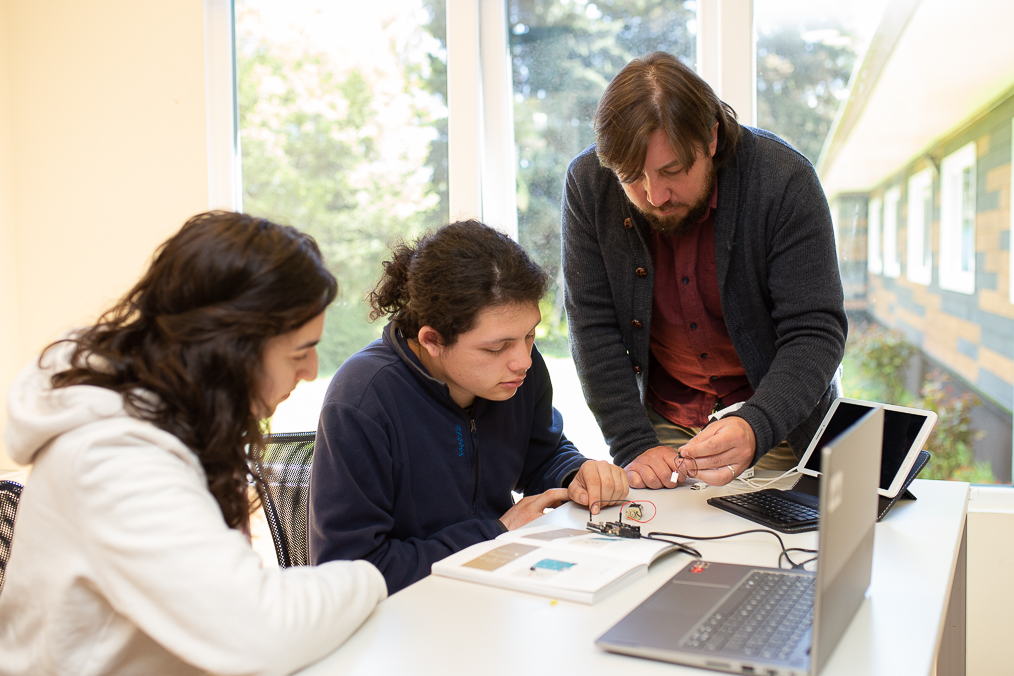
[40,211,338,528]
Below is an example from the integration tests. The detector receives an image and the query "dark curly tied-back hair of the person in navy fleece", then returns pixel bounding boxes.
[368,221,549,346]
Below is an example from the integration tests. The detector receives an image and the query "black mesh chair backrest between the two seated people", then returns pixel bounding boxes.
[258,432,316,568]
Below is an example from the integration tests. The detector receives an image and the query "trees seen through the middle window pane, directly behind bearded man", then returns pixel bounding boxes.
[507,0,697,357]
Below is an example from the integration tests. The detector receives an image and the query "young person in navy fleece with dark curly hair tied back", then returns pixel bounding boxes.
[309,221,629,594]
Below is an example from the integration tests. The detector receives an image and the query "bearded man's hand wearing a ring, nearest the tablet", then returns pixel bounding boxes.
[677,416,757,485]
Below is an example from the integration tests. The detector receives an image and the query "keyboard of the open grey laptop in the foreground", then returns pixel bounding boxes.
[683,571,816,660]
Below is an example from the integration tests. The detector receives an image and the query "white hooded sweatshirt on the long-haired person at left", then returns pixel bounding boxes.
[0,344,386,676]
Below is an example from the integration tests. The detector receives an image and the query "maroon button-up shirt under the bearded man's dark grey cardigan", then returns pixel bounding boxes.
[647,181,753,428]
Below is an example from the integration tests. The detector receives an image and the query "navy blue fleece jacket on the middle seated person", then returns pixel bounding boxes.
[309,324,587,594]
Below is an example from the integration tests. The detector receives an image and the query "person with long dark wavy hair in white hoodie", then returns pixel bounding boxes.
[0,212,385,674]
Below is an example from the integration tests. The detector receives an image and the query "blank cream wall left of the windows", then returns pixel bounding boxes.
[0,0,208,468]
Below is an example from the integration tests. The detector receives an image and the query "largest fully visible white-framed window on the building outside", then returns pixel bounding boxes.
[940,142,975,294]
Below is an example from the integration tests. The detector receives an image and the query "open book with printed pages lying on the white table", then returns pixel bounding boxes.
[433,526,674,603]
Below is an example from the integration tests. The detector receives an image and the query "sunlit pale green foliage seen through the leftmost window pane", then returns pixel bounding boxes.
[236,6,447,374]
